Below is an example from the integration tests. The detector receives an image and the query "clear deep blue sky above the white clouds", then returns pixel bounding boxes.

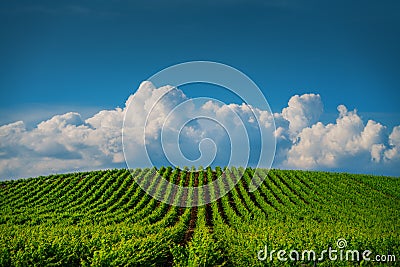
[0,0,400,180]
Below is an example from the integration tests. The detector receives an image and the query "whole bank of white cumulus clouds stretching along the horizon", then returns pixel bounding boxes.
[0,82,400,180]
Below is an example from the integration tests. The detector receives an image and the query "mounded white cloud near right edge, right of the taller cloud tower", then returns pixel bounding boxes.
[284,105,397,173]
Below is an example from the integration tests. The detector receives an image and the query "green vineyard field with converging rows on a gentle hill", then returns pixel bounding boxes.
[0,167,400,266]
